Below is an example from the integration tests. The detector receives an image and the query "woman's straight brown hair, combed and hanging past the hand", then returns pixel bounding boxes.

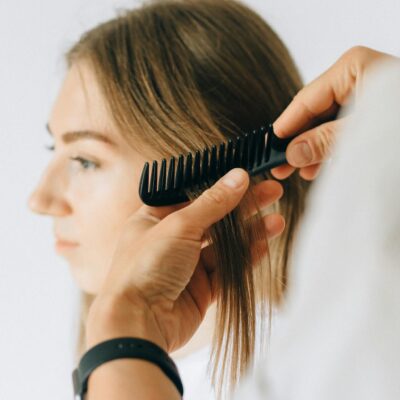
[66,0,310,394]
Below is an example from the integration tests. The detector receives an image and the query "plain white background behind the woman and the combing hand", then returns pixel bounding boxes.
[0,0,400,400]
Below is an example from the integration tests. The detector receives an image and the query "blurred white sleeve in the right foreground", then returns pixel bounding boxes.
[233,59,400,400]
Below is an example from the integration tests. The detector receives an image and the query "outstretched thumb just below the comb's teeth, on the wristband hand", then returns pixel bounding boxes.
[170,168,250,236]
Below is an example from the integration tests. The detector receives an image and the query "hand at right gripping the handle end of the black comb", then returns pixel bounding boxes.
[271,46,395,180]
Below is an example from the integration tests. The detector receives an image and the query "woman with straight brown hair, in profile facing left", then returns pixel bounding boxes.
[30,0,317,398]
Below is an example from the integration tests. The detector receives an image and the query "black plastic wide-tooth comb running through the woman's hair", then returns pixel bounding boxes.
[139,124,293,206]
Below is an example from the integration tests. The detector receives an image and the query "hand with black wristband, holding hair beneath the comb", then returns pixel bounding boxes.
[87,168,285,352]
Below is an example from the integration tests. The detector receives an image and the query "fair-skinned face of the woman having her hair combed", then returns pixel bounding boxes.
[29,64,156,294]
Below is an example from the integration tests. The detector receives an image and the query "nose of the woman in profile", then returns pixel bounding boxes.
[28,171,71,216]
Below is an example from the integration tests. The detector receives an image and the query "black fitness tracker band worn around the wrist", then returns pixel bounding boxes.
[72,337,183,400]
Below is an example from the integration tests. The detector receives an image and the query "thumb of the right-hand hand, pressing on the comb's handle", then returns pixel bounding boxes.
[286,118,343,168]
